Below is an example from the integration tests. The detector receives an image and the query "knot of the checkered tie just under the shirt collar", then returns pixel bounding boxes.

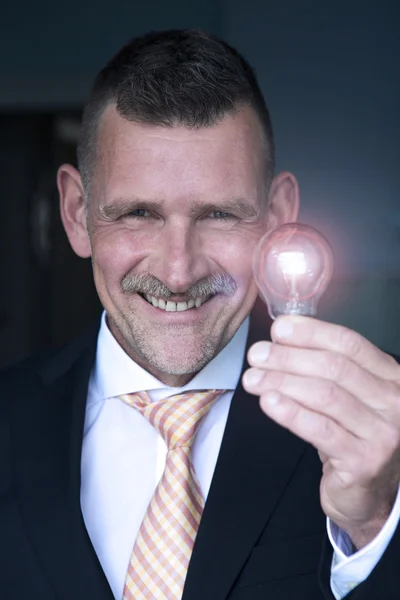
[121,390,225,450]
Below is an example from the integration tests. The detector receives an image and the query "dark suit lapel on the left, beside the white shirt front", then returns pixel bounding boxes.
[15,329,113,600]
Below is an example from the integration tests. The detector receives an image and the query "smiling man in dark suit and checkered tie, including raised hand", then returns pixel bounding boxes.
[0,31,400,600]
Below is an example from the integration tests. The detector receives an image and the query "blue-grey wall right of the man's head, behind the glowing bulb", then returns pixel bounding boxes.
[222,0,400,352]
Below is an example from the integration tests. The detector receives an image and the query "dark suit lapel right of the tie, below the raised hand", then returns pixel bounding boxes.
[183,308,306,600]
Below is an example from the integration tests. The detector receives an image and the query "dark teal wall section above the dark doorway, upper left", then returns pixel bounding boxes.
[0,0,222,110]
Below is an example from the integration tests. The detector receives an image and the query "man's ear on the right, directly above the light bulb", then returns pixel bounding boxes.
[268,171,300,229]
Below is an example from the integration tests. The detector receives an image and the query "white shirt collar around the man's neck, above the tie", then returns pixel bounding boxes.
[92,312,249,400]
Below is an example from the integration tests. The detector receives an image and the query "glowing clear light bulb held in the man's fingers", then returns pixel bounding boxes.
[253,223,333,319]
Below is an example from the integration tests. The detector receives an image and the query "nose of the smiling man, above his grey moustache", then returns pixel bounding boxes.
[150,222,207,294]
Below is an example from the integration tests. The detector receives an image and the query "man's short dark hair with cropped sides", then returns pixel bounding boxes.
[77,29,275,190]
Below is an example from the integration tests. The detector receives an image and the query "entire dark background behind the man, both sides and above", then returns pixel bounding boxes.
[0,0,400,364]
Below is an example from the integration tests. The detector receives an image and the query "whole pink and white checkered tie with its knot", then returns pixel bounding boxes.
[121,390,224,600]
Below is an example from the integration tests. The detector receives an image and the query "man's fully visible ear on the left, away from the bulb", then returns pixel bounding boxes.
[57,165,92,258]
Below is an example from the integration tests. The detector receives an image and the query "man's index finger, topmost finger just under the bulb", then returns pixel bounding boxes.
[271,315,400,380]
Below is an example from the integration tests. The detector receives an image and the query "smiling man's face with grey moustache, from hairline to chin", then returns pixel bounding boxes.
[87,106,267,385]
